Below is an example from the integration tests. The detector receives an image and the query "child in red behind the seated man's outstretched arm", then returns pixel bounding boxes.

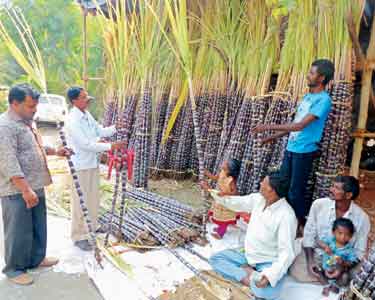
[201,159,241,239]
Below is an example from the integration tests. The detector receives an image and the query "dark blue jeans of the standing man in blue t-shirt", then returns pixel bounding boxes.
[280,151,318,224]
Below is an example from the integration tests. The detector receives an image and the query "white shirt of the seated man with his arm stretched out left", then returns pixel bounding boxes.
[211,191,297,287]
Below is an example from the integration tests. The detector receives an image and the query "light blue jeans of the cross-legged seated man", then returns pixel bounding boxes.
[209,249,284,300]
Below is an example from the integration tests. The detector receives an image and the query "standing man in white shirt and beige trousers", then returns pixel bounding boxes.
[65,87,124,251]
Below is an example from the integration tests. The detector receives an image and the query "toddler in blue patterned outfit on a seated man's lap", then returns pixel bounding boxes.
[318,218,358,296]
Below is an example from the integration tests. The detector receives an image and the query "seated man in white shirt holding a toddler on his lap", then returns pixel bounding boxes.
[290,176,370,285]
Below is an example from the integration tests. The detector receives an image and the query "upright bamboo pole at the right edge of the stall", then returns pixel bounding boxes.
[350,14,375,177]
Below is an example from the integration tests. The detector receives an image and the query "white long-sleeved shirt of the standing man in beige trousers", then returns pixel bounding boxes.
[65,107,116,171]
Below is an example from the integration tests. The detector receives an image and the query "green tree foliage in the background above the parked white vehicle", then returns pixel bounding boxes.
[0,0,104,115]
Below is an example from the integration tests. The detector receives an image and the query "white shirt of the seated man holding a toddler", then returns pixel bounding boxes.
[302,198,371,259]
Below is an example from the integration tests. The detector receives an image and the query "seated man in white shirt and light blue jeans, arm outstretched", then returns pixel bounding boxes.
[210,173,297,299]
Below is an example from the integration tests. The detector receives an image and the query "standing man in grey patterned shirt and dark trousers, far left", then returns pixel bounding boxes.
[0,84,70,285]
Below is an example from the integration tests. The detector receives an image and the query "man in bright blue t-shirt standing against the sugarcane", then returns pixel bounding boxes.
[252,59,334,232]
